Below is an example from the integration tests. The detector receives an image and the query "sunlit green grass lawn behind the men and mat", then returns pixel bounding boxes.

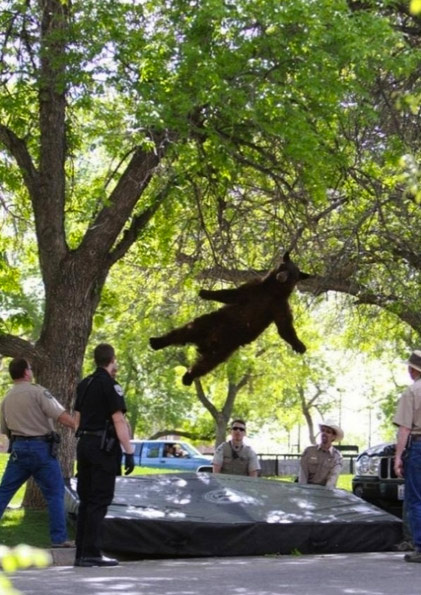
[0,453,352,548]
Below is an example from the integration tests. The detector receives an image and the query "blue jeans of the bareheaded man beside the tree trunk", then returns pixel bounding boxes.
[0,440,67,543]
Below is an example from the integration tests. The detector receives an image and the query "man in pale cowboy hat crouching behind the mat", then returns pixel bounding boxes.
[298,422,344,488]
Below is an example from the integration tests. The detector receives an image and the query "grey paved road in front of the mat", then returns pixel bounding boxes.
[7,552,421,595]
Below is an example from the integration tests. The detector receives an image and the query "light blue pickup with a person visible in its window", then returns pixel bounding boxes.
[131,440,212,471]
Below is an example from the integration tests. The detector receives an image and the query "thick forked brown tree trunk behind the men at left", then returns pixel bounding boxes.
[8,0,164,505]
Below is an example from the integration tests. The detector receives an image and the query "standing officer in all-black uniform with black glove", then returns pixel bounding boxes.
[74,343,134,566]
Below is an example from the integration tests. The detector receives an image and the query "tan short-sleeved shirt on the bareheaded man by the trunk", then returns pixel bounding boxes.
[1,382,64,436]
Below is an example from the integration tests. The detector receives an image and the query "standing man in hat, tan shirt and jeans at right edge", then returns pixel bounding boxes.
[393,350,421,563]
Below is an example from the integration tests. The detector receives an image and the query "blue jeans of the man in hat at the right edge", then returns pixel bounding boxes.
[405,442,421,551]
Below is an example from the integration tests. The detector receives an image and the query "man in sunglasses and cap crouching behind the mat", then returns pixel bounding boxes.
[213,419,260,477]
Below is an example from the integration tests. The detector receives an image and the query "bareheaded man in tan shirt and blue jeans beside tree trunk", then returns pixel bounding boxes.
[0,358,74,547]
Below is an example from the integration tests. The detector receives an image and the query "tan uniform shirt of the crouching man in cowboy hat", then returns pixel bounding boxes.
[298,446,342,488]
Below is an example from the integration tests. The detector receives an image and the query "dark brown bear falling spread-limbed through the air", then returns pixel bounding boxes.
[149,252,310,386]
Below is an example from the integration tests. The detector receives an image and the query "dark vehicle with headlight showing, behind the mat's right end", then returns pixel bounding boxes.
[352,443,405,518]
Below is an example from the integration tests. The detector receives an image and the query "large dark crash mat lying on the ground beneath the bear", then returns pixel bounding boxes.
[66,473,402,558]
